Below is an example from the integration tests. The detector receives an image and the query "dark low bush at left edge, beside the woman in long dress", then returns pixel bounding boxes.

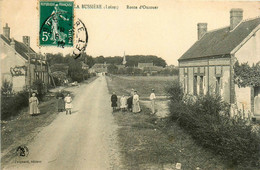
[1,91,29,120]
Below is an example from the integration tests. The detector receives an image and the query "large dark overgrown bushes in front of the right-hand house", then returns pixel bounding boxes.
[168,82,260,167]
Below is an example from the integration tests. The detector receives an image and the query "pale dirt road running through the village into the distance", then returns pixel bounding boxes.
[4,77,121,170]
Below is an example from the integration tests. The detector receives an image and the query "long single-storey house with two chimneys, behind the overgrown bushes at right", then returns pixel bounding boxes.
[178,9,260,117]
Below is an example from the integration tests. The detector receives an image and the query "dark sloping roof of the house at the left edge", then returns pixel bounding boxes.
[0,34,36,60]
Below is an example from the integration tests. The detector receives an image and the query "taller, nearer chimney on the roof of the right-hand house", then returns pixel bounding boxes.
[230,8,243,30]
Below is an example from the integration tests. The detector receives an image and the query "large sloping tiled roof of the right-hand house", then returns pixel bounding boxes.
[179,18,260,61]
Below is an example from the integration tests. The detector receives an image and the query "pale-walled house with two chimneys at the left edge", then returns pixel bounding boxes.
[0,24,49,92]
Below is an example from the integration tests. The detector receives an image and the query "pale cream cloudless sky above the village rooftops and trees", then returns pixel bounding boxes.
[0,0,260,65]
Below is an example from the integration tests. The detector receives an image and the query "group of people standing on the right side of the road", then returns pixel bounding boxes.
[111,89,156,114]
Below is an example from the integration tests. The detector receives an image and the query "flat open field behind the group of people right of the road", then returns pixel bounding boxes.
[107,76,178,98]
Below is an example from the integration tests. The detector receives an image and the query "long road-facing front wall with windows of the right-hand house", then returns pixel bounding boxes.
[179,58,230,102]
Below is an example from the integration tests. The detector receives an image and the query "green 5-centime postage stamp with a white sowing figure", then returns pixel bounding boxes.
[39,1,74,47]
